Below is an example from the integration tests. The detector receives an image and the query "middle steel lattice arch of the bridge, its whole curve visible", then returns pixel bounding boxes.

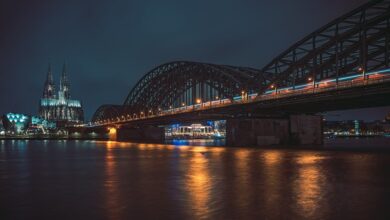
[124,61,260,112]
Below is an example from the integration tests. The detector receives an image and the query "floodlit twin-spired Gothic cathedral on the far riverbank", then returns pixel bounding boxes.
[39,64,84,127]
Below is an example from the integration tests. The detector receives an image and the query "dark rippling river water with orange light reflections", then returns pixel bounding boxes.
[0,139,390,219]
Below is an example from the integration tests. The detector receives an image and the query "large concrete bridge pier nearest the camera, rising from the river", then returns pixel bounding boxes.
[226,115,323,146]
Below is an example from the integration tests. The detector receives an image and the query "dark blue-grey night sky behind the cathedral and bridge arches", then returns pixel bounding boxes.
[0,0,390,120]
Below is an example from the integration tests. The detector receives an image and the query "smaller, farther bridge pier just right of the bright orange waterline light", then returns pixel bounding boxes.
[116,126,165,143]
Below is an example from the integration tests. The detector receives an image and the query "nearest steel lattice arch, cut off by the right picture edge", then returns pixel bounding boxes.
[259,0,390,92]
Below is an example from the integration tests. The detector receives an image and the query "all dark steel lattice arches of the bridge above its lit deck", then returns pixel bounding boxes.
[92,0,390,122]
